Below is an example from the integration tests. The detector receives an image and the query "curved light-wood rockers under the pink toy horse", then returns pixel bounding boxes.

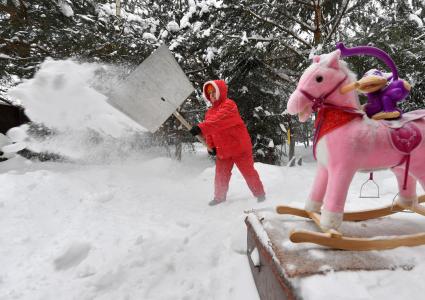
[276,195,425,251]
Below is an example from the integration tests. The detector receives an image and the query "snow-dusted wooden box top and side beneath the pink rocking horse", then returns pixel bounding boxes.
[246,212,425,300]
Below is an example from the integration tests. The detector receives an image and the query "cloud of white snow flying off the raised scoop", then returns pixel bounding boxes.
[9,59,141,136]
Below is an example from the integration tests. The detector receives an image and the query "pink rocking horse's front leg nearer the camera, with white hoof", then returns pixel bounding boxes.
[320,167,355,230]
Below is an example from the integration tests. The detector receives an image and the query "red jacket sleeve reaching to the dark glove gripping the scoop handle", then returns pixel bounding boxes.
[198,100,243,137]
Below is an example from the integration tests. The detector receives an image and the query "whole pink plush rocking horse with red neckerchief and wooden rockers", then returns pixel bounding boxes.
[277,44,425,250]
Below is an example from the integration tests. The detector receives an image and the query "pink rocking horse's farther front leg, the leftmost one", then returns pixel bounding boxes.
[305,164,328,212]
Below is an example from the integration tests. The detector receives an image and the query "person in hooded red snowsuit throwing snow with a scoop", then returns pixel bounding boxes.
[190,80,265,205]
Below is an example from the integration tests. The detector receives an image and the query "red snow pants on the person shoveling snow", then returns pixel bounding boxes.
[214,149,265,201]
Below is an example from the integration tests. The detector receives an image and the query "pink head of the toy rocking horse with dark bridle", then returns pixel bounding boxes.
[287,50,360,122]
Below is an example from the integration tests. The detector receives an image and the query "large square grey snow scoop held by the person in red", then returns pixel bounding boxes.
[110,44,206,145]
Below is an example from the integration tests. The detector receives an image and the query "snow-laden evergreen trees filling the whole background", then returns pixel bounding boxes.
[0,0,425,164]
